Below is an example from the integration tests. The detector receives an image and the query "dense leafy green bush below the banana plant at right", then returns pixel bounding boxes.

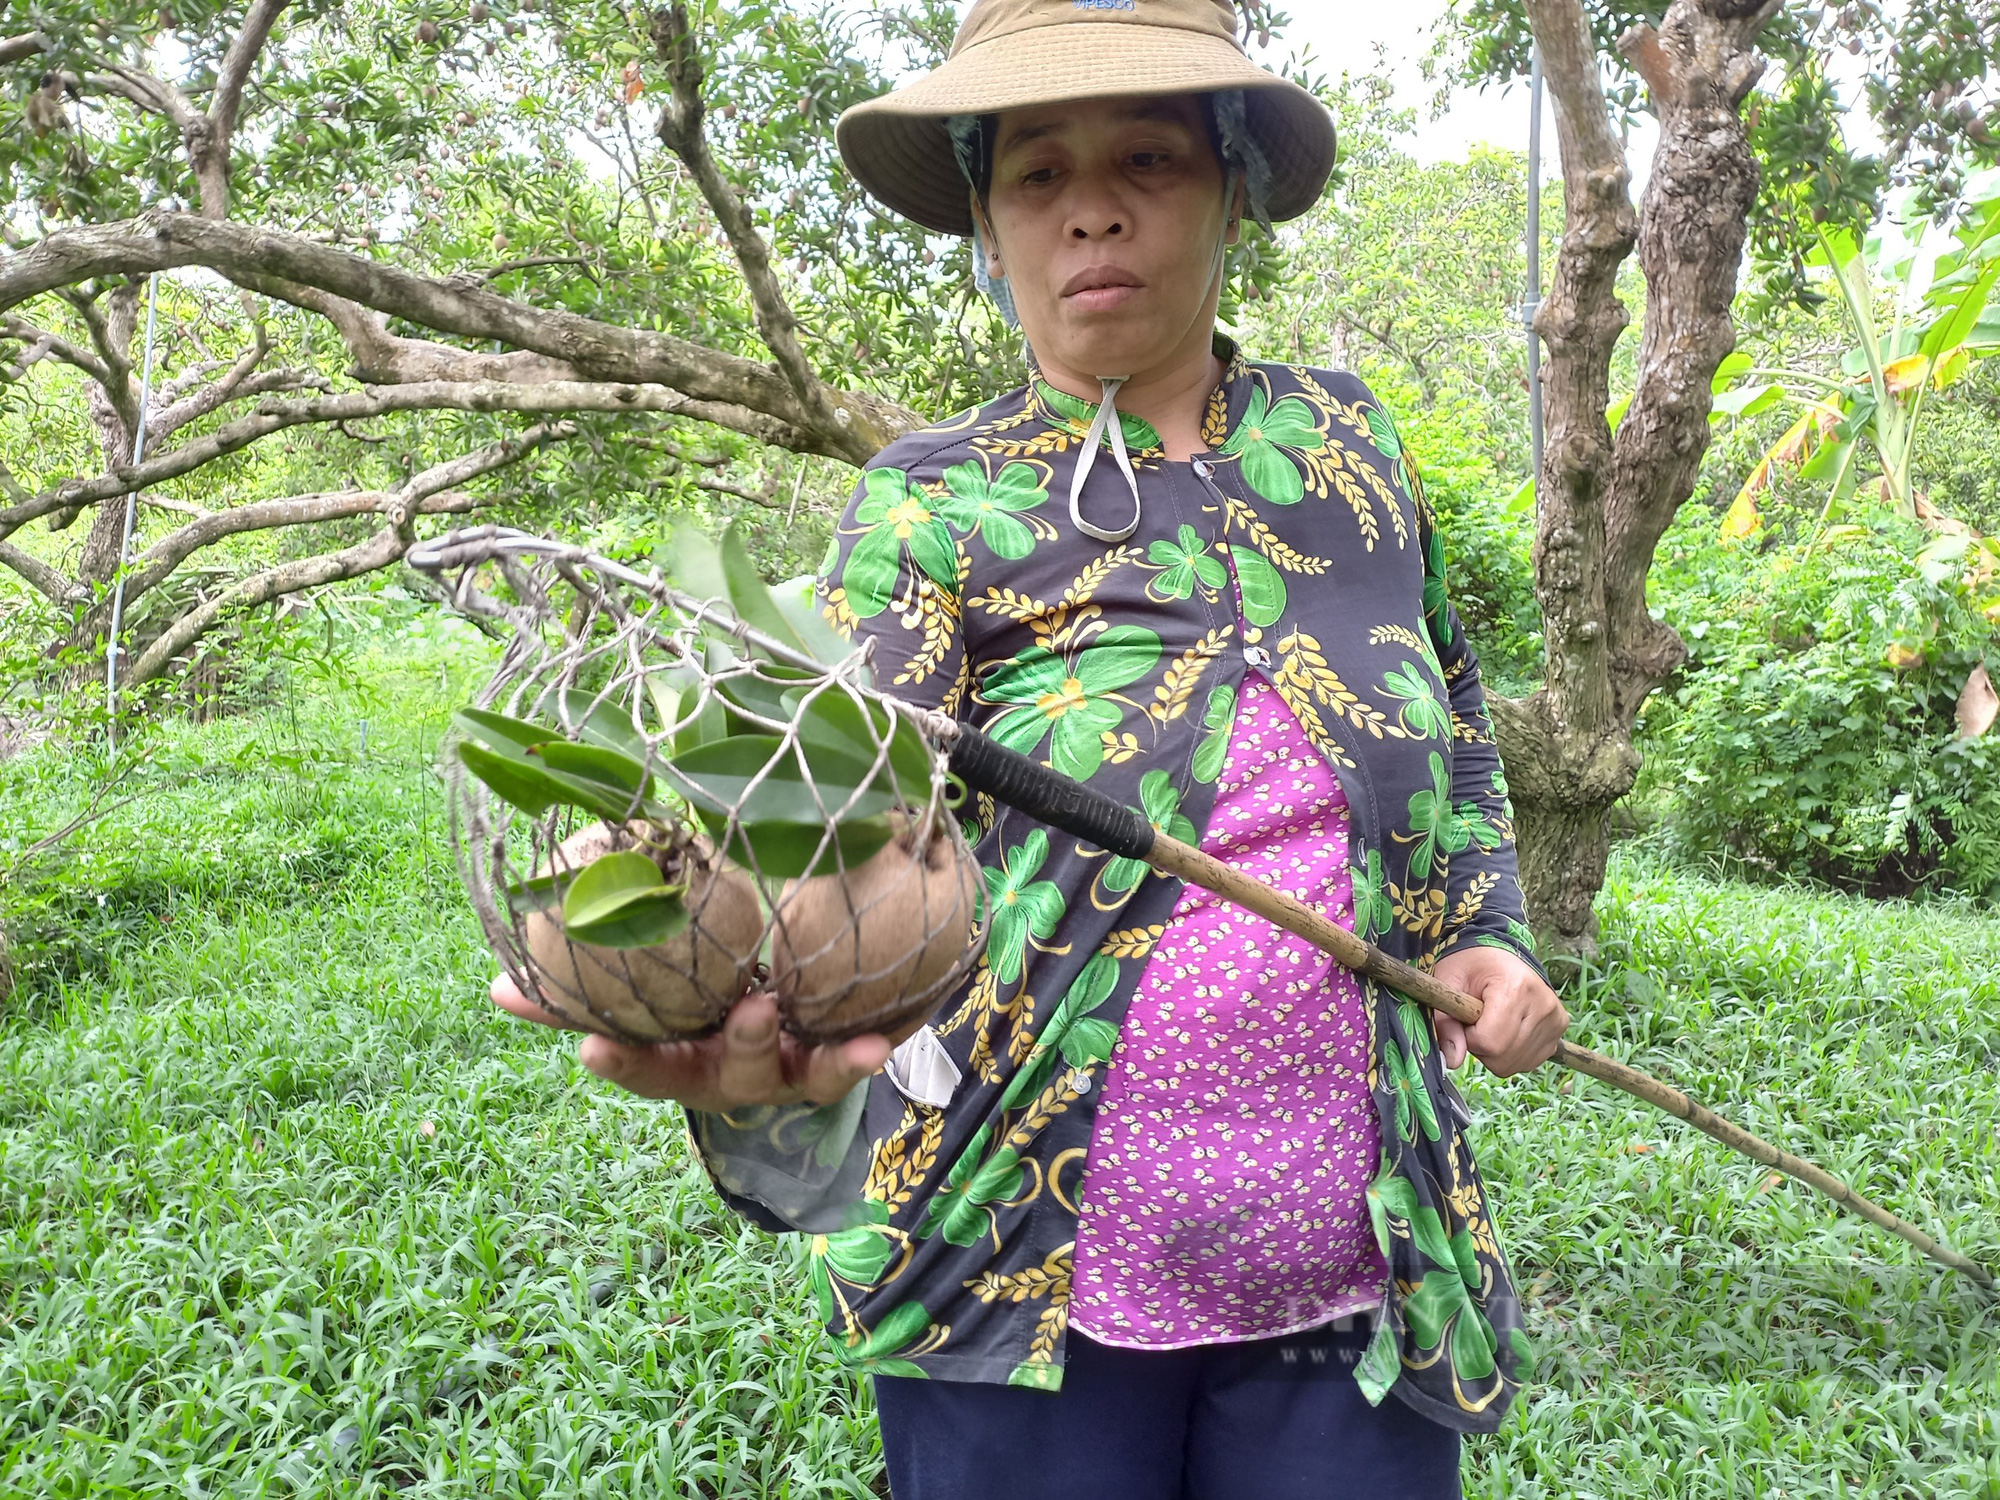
[1646,508,2000,898]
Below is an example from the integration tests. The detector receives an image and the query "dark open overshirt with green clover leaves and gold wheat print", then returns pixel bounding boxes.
[690,342,1534,1432]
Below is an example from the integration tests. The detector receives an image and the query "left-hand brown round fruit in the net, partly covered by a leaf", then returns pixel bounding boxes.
[520,824,764,1042]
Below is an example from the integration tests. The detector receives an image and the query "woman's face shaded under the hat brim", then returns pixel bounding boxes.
[986,94,1224,380]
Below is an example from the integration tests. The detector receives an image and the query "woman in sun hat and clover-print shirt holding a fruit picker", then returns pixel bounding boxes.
[496,0,1568,1500]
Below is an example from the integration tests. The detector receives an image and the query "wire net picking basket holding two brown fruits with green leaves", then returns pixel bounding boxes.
[412,528,986,1044]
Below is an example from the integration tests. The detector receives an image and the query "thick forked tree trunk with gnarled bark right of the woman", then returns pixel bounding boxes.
[1494,0,1780,960]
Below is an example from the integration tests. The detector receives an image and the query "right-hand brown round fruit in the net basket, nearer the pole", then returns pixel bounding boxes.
[770,824,980,1044]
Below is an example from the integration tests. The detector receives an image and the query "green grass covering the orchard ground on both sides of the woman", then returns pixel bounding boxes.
[0,630,2000,1498]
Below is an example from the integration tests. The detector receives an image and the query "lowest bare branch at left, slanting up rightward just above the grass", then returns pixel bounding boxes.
[130,422,574,684]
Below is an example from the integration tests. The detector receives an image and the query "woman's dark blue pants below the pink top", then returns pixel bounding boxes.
[874,1318,1458,1500]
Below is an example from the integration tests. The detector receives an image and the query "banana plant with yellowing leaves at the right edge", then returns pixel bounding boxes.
[1718,168,2000,538]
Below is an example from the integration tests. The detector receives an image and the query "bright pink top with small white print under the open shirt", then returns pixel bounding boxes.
[1070,672,1388,1348]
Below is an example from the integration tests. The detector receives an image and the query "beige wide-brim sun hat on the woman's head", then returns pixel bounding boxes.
[836,0,1334,236]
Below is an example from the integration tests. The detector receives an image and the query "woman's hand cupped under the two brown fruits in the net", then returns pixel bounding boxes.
[490,974,890,1114]
